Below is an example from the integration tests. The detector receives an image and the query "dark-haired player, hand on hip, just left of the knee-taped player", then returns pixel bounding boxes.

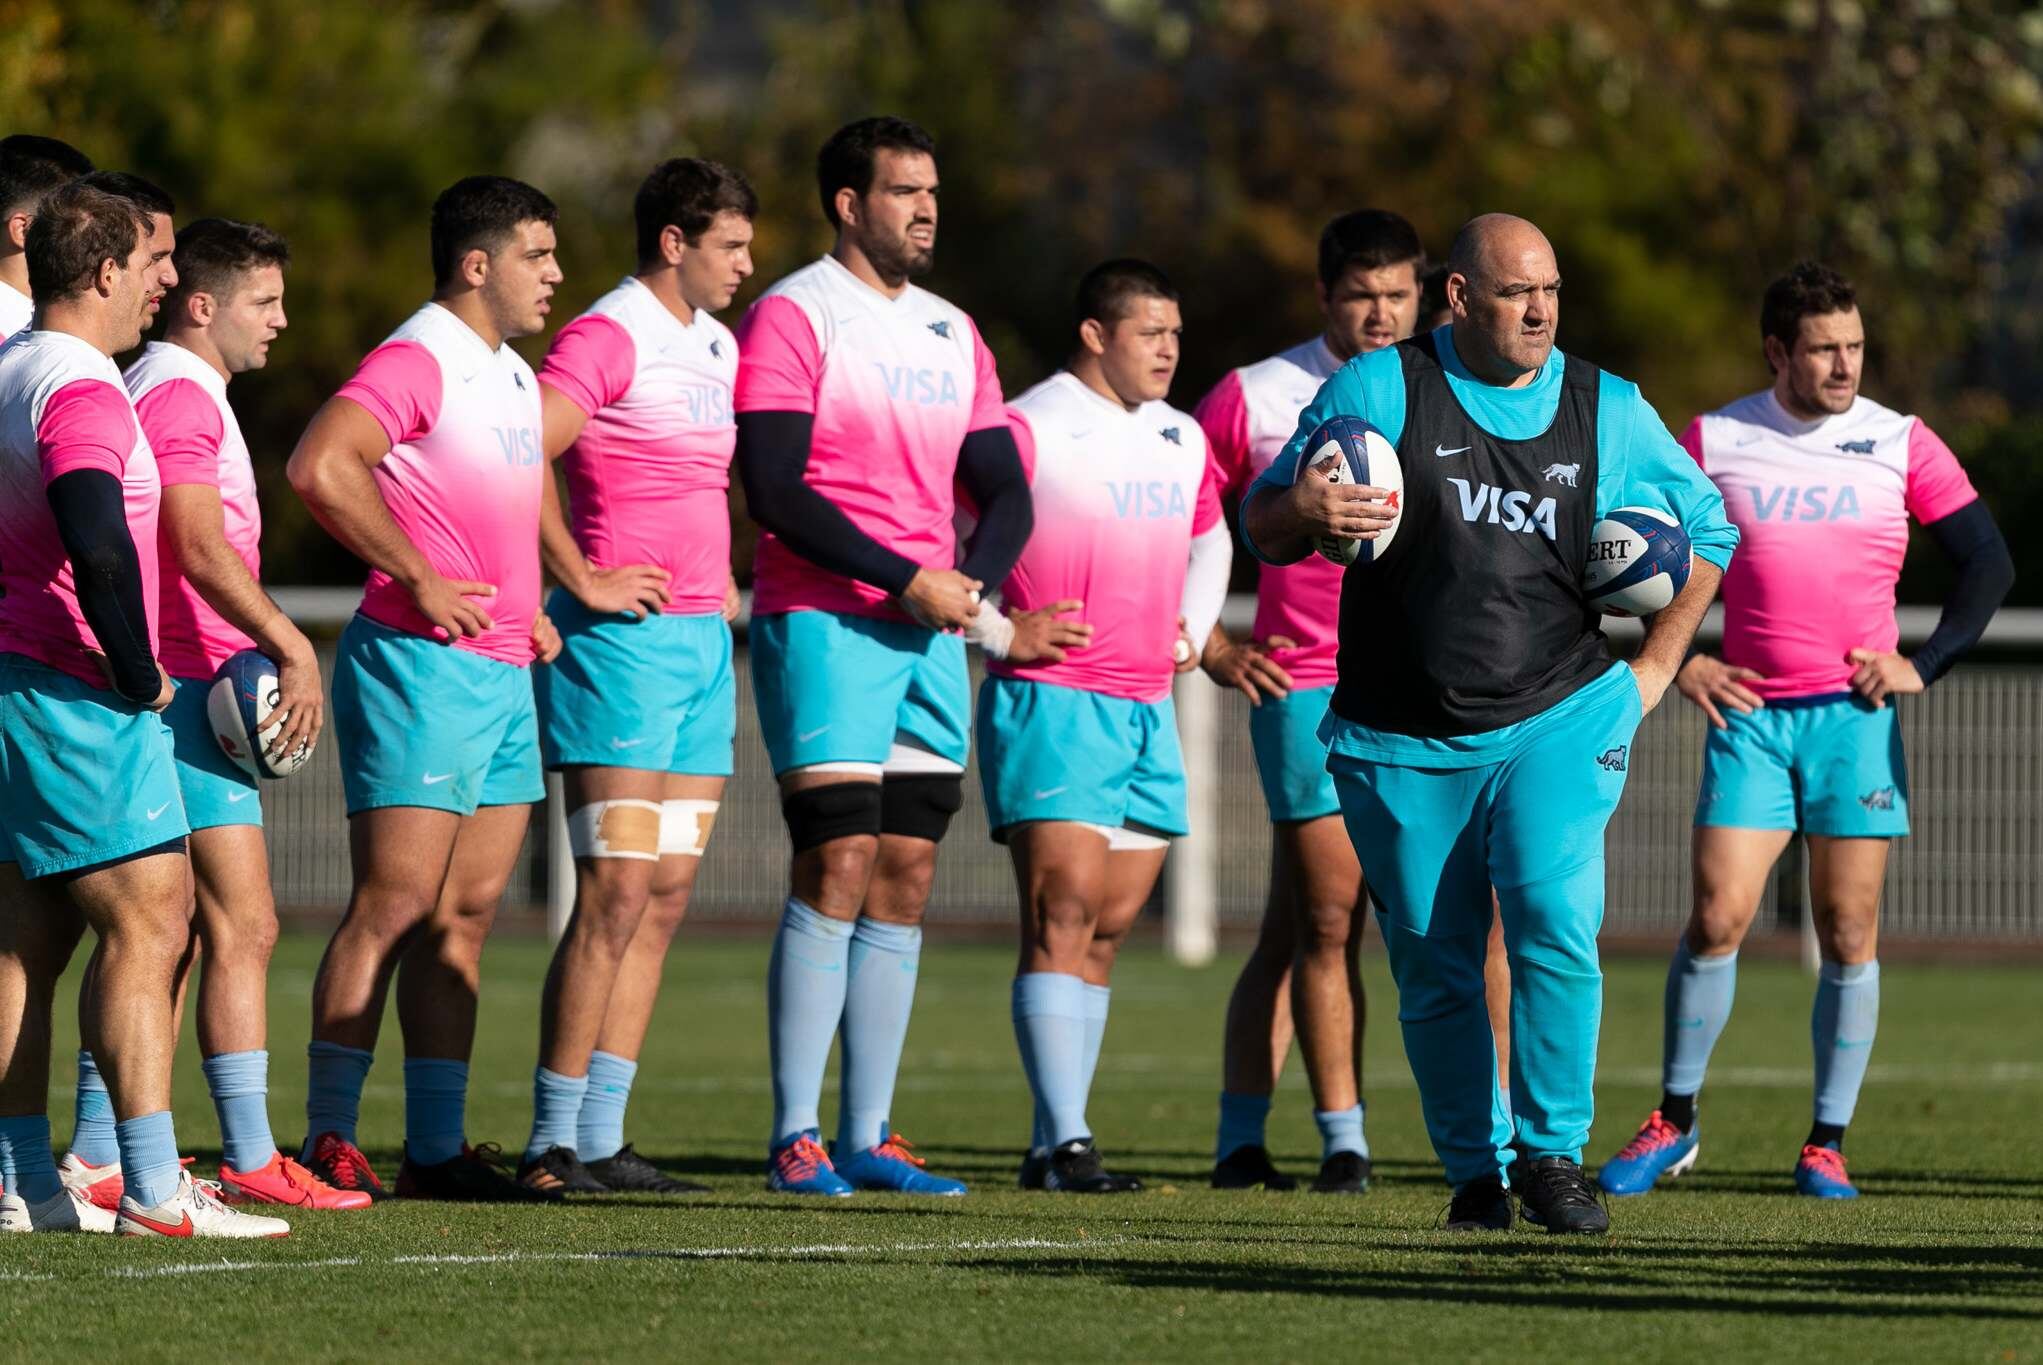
[288,176,562,1202]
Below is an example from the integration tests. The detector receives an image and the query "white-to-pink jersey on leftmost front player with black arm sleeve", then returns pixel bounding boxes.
[0,331,163,689]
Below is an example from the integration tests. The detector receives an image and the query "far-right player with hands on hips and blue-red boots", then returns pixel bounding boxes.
[1598,264,2014,1199]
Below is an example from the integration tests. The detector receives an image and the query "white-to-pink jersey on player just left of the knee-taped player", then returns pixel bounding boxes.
[339,302,548,666]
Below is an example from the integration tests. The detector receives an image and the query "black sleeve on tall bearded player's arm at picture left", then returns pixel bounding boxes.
[738,413,921,597]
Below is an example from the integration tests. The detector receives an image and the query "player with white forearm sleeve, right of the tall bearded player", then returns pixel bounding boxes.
[975,260,1232,1193]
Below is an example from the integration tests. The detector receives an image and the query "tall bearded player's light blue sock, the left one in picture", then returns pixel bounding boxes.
[766,897,852,1146]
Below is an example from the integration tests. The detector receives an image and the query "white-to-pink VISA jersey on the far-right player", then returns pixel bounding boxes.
[1681,390,1980,697]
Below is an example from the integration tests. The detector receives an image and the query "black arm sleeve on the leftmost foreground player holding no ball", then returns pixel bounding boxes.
[47,470,163,705]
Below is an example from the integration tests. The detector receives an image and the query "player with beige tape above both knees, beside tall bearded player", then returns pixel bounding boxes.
[519,157,758,1193]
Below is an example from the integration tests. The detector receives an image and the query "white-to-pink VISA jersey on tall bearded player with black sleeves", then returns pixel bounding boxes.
[738,255,1007,621]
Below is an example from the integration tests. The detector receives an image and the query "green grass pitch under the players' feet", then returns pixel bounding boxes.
[0,934,2043,1365]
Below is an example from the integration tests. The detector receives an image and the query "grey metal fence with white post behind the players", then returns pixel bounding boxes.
[262,593,2043,956]
